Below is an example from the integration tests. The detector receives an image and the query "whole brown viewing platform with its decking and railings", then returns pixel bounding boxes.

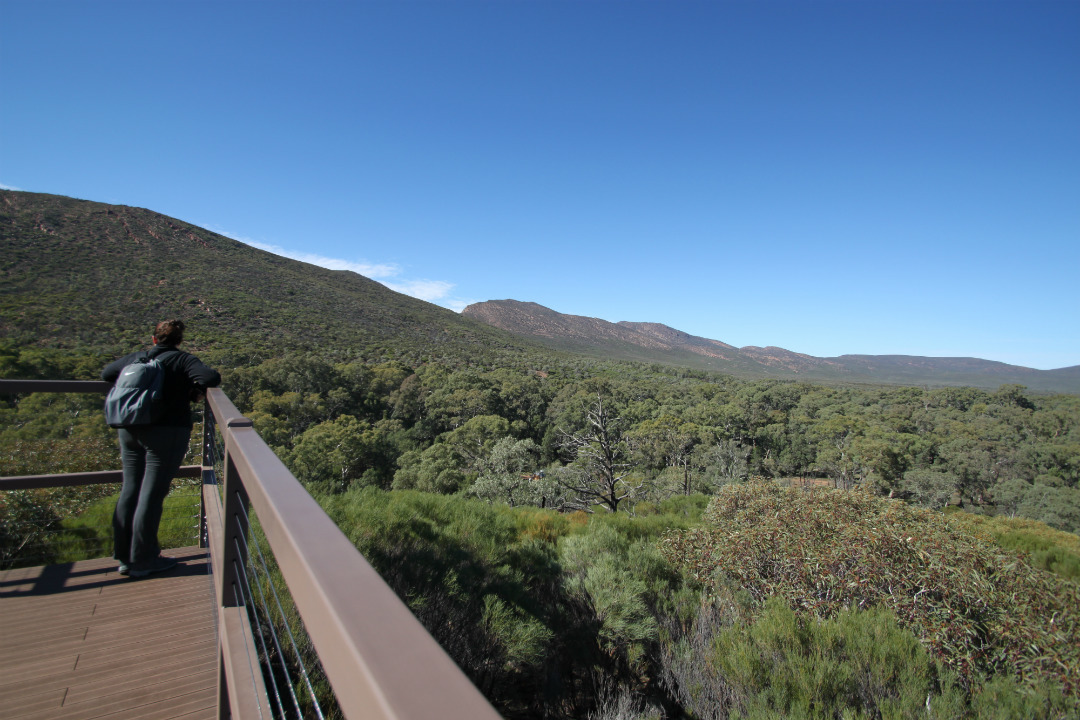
[0,380,499,720]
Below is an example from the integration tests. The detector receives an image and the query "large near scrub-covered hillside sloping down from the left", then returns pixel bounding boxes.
[0,191,528,359]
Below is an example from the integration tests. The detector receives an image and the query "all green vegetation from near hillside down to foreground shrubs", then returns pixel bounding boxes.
[6,191,1080,720]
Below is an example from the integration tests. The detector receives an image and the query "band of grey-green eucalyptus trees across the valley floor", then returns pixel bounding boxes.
[8,336,1080,532]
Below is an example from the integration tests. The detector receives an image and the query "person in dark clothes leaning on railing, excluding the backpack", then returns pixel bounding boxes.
[102,320,221,578]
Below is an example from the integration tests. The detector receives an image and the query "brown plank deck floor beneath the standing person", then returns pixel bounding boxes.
[0,547,217,720]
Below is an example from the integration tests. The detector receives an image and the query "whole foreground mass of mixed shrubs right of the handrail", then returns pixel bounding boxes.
[304,484,1078,718]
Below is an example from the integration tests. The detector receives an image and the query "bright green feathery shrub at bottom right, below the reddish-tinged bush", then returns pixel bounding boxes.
[664,598,1075,720]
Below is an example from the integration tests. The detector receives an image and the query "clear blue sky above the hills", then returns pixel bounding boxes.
[0,0,1080,368]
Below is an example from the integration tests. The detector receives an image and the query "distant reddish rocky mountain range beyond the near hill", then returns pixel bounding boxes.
[463,300,1080,393]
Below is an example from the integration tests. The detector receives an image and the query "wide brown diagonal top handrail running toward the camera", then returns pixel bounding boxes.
[204,390,499,720]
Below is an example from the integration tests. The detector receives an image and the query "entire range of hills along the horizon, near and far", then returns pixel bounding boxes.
[0,190,1080,393]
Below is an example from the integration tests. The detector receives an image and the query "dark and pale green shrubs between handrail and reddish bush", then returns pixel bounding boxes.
[320,488,696,718]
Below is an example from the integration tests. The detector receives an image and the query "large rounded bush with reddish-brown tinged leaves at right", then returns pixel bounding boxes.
[662,483,1080,697]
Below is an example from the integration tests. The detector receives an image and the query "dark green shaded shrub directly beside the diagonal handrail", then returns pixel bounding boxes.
[320,487,572,715]
